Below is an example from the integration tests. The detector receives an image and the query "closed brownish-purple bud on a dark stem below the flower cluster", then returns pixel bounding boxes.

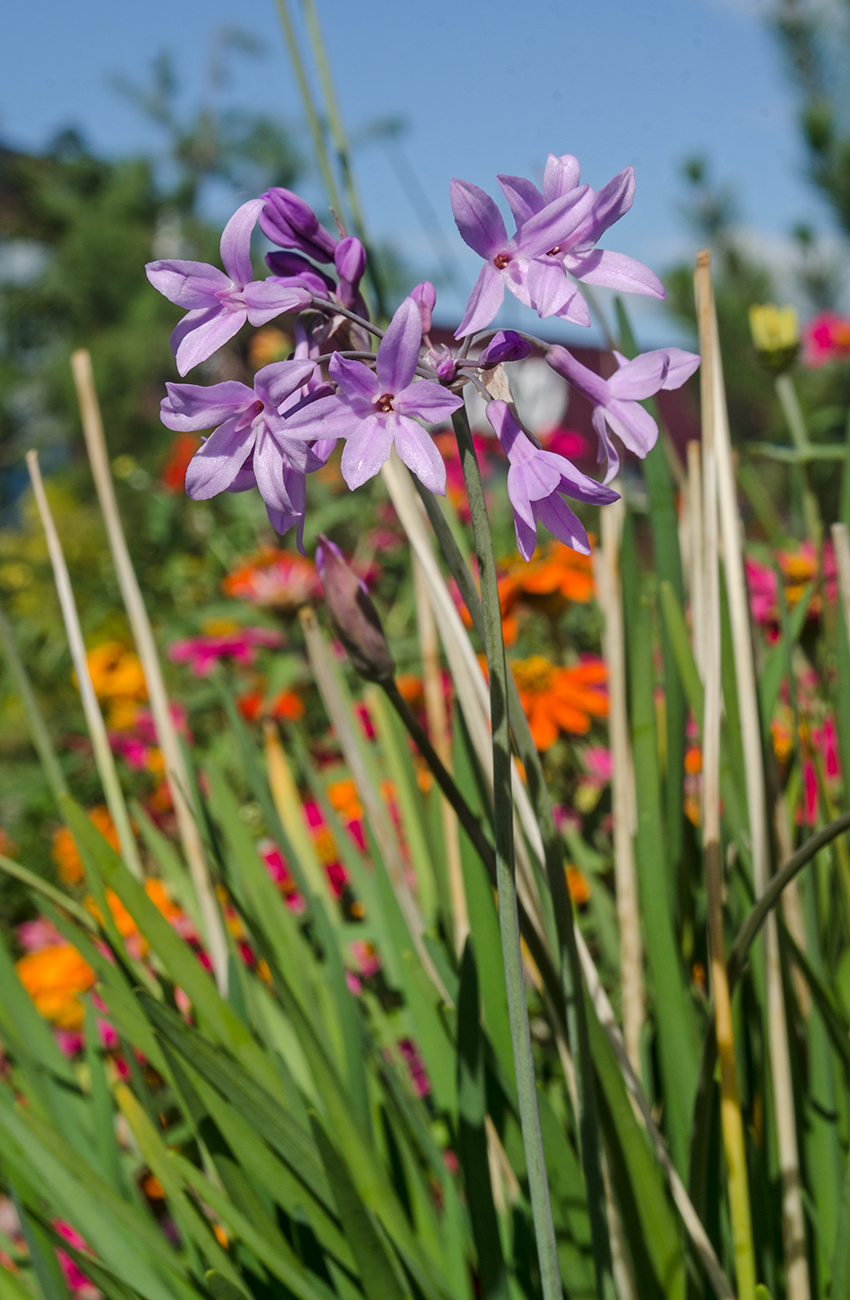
[316,533,395,683]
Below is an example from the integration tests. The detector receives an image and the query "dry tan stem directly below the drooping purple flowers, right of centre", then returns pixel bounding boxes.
[595,498,646,1075]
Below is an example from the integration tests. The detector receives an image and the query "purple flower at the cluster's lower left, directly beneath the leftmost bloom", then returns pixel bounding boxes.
[161,361,324,546]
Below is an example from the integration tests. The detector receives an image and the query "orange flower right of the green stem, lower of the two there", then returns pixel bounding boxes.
[511,655,608,750]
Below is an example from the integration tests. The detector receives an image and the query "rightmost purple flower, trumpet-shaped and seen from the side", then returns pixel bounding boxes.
[546,347,699,482]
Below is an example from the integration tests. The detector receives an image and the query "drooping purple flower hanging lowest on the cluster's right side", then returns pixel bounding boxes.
[487,402,617,560]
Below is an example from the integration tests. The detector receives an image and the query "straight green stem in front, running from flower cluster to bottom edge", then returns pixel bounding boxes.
[452,411,561,1300]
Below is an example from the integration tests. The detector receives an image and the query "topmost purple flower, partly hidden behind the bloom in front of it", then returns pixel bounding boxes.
[498,153,664,298]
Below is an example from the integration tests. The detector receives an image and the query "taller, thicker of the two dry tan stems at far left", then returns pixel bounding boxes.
[71,348,227,995]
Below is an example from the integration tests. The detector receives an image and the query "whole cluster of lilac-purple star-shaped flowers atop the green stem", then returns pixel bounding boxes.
[147,155,699,559]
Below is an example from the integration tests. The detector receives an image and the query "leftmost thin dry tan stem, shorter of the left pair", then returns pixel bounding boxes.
[26,451,143,880]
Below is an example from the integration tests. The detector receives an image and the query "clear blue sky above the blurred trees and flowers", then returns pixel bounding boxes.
[0,0,829,334]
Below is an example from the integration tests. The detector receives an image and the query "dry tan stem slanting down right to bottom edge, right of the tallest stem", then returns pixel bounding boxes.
[708,269,811,1300]
